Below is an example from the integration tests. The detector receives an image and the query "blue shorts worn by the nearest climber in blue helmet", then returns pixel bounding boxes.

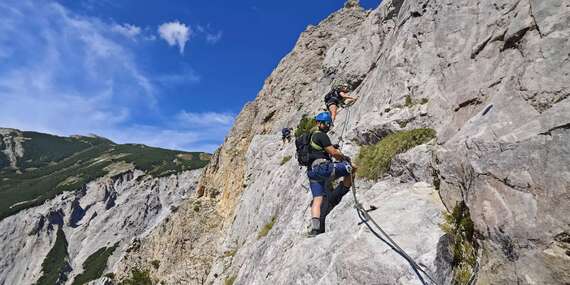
[307,161,352,197]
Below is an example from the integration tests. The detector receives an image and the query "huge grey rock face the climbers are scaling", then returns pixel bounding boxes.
[119,0,570,284]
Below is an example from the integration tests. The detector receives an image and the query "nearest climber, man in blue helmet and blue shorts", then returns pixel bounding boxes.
[307,112,356,237]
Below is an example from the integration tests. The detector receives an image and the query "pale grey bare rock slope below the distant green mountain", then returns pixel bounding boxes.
[0,170,201,284]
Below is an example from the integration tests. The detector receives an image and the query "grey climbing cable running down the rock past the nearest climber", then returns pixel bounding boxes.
[339,102,438,285]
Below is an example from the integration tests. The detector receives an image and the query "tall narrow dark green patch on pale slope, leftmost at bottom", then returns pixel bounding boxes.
[36,226,71,285]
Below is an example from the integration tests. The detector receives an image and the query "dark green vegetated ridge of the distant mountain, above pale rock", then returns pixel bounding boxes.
[0,132,209,220]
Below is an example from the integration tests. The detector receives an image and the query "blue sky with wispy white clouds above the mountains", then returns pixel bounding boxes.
[0,0,379,152]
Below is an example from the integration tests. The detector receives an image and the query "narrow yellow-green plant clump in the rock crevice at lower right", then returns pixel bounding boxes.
[440,202,477,285]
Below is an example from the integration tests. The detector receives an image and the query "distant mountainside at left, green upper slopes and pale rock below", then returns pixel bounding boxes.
[0,129,208,284]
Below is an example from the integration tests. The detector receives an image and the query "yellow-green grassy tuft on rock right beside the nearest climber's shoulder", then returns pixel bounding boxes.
[357,129,436,180]
